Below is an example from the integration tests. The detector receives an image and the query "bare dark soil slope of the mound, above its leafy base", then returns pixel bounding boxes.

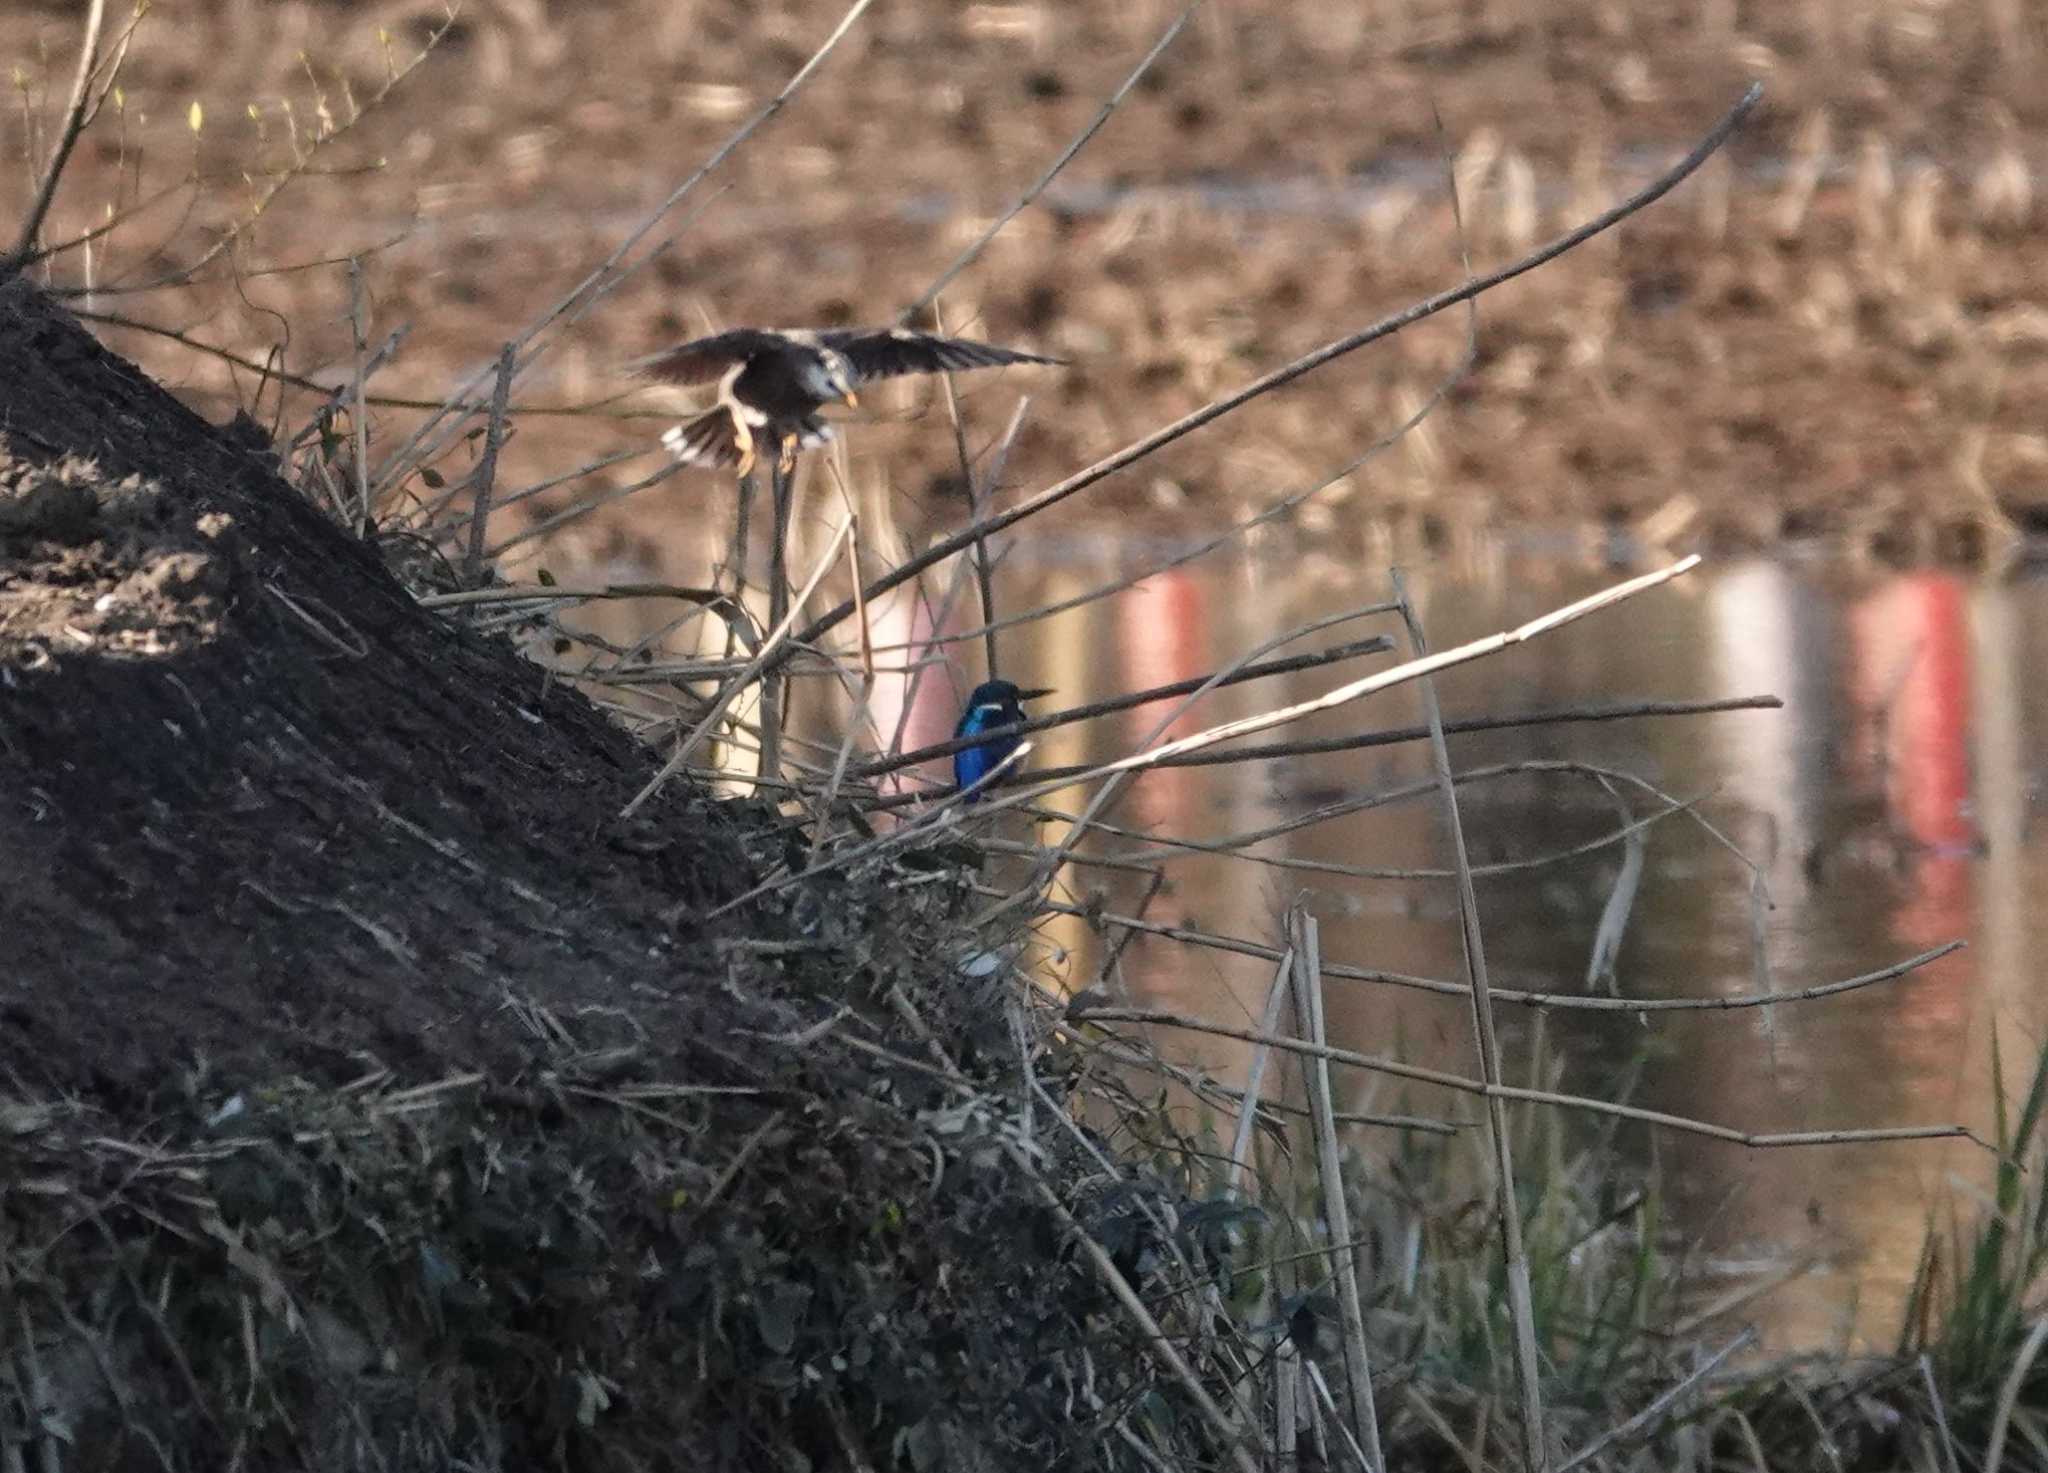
[0,285,774,1088]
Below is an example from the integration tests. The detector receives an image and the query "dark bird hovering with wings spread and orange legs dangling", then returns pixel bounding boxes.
[637,328,1065,475]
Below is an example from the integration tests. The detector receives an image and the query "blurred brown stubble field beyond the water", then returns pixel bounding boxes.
[0,0,2048,565]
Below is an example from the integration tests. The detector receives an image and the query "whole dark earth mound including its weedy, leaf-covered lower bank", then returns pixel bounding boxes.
[0,283,1221,1473]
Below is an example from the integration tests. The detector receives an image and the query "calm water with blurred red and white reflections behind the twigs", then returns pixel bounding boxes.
[920,555,2048,1348]
